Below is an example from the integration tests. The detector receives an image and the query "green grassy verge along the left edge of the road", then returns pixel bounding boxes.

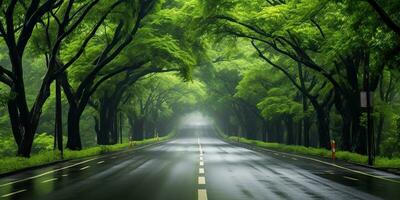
[0,133,174,174]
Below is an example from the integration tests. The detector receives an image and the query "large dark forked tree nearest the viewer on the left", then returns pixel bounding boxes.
[0,0,126,157]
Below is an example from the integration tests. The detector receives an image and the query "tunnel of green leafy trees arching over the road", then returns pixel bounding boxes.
[0,0,400,166]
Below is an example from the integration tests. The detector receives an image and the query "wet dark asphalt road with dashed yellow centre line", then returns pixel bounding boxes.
[0,128,400,200]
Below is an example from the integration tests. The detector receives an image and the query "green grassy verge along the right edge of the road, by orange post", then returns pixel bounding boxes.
[223,136,400,170]
